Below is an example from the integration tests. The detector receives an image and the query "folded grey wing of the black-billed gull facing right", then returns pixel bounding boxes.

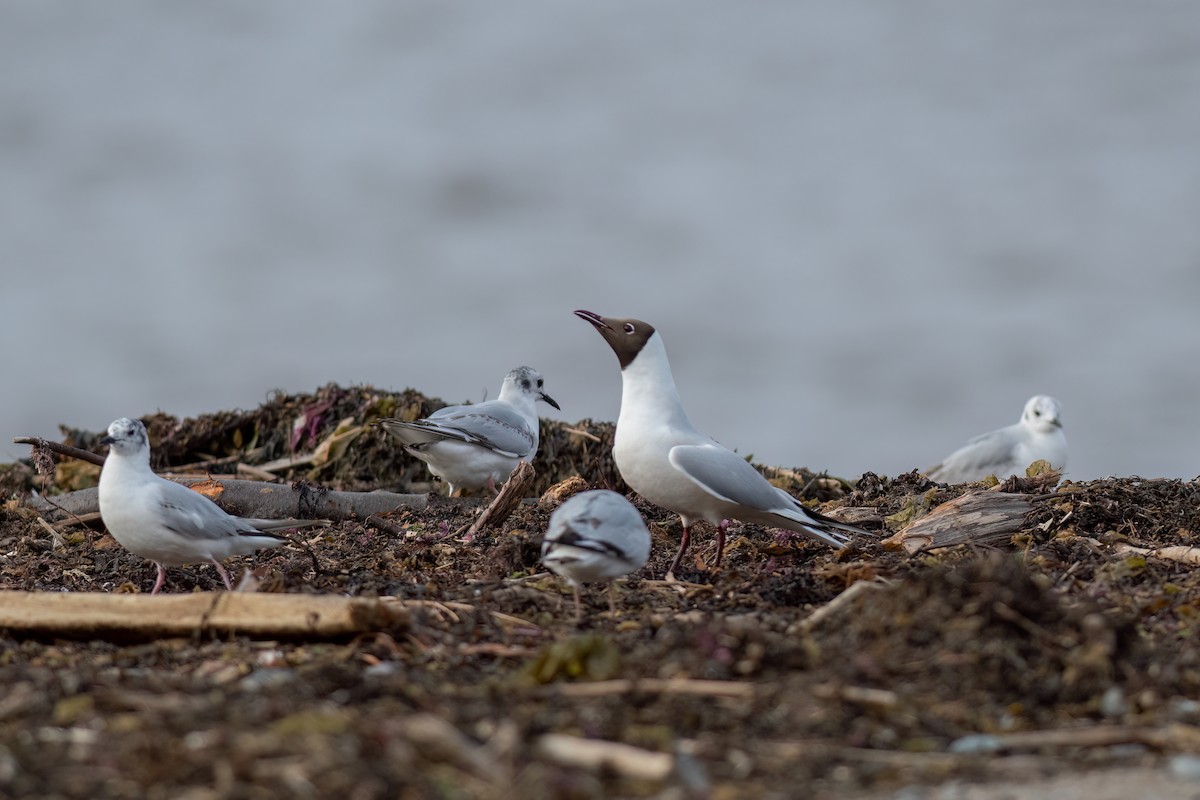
[379,401,534,458]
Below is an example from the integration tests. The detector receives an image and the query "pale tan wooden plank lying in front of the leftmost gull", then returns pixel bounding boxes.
[0,591,409,640]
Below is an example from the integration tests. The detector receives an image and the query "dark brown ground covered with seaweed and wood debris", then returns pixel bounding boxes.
[0,386,1200,800]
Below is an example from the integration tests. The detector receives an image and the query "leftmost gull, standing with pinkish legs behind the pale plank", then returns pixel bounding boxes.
[100,417,324,595]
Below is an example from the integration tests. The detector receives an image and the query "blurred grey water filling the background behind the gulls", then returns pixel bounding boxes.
[0,0,1200,479]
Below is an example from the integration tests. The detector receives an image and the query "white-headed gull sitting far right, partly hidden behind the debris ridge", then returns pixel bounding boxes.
[925,395,1067,483]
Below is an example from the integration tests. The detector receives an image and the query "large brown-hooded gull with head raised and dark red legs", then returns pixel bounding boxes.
[575,311,866,579]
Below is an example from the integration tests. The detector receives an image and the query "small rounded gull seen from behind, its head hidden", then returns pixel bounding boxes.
[541,489,650,619]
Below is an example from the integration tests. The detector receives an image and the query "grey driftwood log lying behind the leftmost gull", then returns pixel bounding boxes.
[30,477,428,521]
